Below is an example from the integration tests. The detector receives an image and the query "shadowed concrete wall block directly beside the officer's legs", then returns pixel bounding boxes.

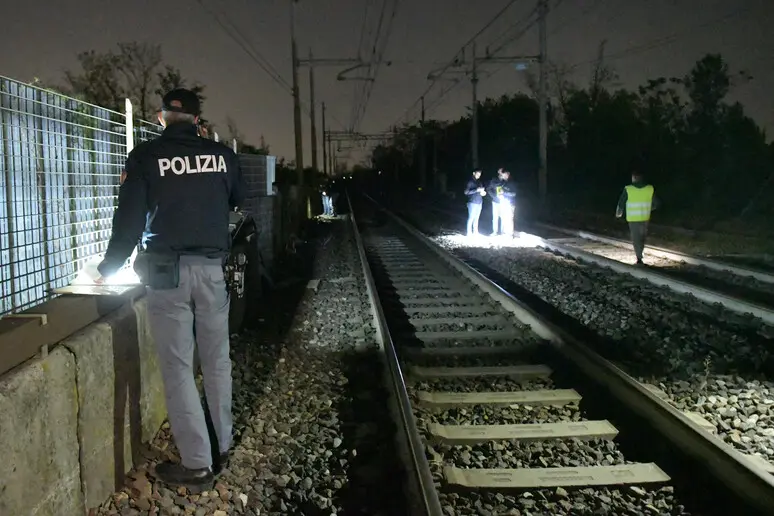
[61,300,166,508]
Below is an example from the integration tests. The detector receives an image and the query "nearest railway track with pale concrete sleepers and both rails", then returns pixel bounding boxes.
[355,196,774,514]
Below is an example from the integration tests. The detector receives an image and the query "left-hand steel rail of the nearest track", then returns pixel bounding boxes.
[347,194,444,516]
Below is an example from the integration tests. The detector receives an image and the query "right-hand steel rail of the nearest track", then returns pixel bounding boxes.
[365,195,774,514]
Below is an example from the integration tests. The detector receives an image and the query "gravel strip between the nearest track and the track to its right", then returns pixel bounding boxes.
[438,237,774,460]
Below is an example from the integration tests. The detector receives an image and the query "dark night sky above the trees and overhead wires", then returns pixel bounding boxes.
[0,0,774,165]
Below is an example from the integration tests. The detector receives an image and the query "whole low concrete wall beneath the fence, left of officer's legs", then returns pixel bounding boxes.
[0,299,166,516]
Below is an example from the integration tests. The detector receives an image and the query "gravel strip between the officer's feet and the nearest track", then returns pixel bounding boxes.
[97,220,403,516]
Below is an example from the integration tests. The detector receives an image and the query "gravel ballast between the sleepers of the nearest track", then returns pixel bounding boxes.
[358,231,685,515]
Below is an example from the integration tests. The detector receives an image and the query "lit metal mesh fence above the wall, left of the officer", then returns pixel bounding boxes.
[0,77,160,316]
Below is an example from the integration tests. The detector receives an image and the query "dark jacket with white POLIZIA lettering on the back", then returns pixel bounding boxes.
[99,123,245,276]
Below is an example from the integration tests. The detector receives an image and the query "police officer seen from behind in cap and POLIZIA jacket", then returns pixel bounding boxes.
[99,89,244,492]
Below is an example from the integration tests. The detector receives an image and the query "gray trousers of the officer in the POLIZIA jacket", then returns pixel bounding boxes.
[148,256,233,469]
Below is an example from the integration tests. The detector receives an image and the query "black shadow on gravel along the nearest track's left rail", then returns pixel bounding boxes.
[326,350,409,516]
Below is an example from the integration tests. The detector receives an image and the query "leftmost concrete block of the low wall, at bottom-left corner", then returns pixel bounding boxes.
[0,348,84,516]
